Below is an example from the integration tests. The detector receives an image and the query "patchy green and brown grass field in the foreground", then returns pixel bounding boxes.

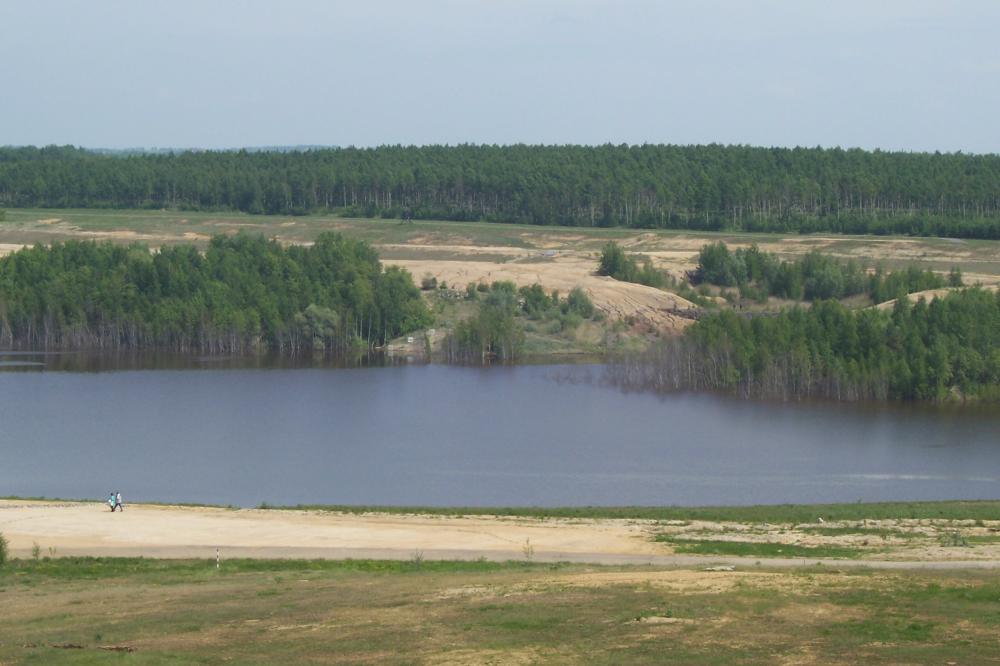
[0,558,1000,664]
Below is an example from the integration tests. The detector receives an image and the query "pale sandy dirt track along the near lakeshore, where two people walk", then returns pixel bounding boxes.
[0,500,1000,569]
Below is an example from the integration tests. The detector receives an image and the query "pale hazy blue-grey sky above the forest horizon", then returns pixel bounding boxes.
[0,0,1000,152]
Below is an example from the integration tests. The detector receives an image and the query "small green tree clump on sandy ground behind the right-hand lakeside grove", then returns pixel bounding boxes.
[694,241,962,303]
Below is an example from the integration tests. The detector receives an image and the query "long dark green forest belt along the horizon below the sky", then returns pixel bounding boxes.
[0,144,1000,238]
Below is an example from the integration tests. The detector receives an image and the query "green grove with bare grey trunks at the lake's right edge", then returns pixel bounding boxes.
[611,288,1000,400]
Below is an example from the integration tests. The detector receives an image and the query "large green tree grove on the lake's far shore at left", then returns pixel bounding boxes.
[0,233,430,352]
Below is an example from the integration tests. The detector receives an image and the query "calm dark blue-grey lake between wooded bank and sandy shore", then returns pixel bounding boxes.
[0,356,1000,506]
